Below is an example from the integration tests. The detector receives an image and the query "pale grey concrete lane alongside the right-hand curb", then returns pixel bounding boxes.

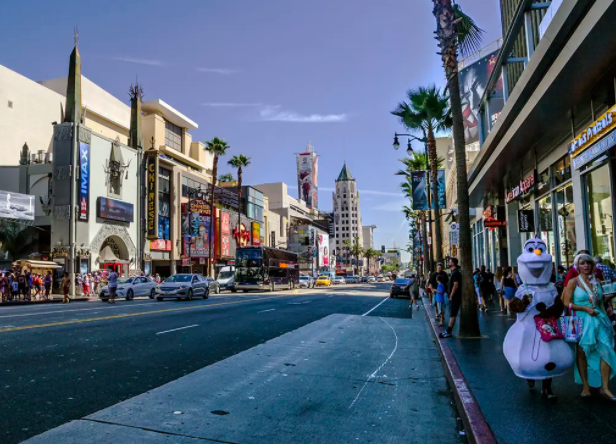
[26,314,462,444]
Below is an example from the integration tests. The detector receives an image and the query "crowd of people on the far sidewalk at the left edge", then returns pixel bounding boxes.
[0,269,53,302]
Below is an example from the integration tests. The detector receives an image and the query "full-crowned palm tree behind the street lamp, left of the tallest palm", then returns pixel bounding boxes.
[391,85,452,268]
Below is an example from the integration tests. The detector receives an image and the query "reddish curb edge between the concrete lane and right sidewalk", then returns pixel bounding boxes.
[421,297,497,444]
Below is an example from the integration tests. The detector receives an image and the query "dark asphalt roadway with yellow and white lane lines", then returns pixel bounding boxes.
[0,284,423,443]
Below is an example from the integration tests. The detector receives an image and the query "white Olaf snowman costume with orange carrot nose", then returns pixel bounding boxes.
[503,239,574,380]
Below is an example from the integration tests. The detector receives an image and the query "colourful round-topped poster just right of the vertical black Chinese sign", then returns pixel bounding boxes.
[182,199,211,258]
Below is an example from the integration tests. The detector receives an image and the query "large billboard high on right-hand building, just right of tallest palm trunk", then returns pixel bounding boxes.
[458,51,504,145]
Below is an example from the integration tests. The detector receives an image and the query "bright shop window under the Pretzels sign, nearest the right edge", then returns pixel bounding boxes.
[586,165,614,263]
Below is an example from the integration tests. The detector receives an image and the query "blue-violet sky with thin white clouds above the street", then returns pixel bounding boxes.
[0,0,501,260]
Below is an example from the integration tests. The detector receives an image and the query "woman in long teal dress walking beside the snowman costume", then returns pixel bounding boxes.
[563,254,616,401]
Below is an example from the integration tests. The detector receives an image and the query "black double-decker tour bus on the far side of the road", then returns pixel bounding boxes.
[235,246,299,292]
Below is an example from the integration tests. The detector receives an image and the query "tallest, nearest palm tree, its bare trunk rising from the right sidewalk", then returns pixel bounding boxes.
[432,0,483,337]
